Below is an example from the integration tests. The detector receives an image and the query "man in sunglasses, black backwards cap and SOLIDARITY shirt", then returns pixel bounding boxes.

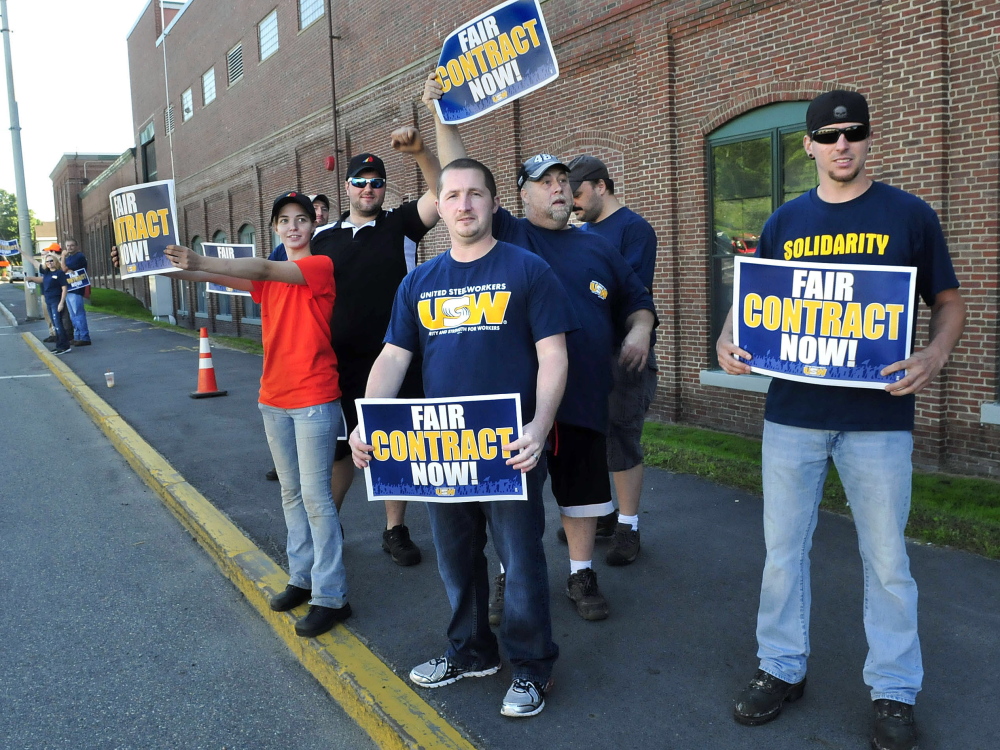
[716,91,965,750]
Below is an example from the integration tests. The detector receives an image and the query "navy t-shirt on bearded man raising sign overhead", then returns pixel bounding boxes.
[493,208,655,432]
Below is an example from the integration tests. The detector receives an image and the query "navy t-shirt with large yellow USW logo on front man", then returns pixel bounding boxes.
[385,242,578,423]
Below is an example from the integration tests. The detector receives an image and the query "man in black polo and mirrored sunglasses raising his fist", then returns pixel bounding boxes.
[271,127,441,565]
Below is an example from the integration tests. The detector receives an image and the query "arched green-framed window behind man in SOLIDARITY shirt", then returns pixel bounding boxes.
[707,102,817,363]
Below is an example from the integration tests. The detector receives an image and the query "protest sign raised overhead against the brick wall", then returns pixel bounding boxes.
[434,0,559,125]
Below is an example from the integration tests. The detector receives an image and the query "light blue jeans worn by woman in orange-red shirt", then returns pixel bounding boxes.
[258,401,347,608]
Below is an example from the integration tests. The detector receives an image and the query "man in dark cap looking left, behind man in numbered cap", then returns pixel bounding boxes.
[560,154,656,565]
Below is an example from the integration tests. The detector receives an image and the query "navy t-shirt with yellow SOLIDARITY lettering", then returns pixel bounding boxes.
[758,182,958,431]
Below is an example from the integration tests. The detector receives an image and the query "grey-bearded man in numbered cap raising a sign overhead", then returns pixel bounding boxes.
[423,74,656,620]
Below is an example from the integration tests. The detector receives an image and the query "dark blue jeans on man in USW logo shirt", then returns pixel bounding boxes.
[427,462,559,684]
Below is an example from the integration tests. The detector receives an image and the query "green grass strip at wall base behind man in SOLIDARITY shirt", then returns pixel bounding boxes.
[643,422,1000,559]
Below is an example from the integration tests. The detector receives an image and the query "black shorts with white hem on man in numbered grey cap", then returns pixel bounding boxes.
[548,422,615,518]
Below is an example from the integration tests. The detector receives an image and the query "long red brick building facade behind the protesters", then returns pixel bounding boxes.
[58,0,1000,475]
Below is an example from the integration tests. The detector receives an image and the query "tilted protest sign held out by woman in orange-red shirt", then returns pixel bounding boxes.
[111,180,180,279]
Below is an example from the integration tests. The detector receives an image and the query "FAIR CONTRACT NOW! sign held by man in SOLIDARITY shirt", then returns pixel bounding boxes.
[733,258,917,389]
